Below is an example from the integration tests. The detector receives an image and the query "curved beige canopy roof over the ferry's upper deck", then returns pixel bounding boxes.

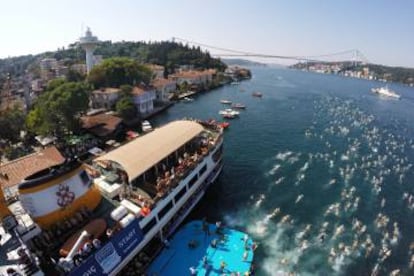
[95,121,204,181]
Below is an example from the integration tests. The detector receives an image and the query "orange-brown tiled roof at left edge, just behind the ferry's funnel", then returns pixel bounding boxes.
[0,146,65,198]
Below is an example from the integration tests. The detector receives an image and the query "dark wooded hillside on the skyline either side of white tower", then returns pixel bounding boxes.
[0,41,227,87]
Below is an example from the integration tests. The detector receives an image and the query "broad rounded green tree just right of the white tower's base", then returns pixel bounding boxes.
[88,57,152,88]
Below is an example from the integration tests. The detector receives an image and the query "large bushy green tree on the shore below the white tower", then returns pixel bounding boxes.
[26,82,90,137]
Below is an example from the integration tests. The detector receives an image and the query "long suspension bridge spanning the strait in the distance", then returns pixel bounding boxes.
[172,37,369,64]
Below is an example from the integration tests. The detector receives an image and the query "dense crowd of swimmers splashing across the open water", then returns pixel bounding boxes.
[247,98,414,275]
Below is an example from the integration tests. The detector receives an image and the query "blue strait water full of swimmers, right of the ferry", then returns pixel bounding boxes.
[152,67,414,275]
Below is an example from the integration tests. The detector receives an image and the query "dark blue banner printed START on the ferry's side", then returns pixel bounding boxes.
[70,219,144,276]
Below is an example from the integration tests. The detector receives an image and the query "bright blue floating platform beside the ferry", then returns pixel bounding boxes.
[147,221,254,276]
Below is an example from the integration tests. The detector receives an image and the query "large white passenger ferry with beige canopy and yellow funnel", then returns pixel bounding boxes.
[0,120,223,275]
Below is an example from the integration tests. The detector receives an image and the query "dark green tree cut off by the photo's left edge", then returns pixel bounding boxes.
[0,106,25,143]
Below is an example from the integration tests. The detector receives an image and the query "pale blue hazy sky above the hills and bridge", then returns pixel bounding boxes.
[0,0,414,67]
